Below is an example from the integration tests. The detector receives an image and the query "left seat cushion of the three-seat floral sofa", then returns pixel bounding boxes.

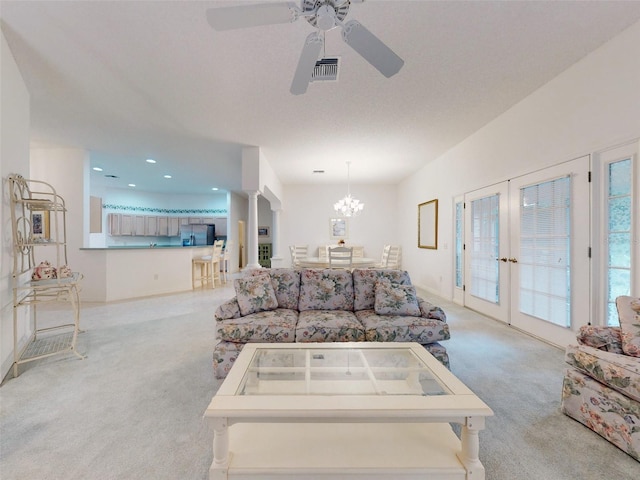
[216,308,298,343]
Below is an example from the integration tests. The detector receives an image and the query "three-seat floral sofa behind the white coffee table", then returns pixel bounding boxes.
[213,268,449,379]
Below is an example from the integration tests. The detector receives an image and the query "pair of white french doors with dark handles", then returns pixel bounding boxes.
[464,156,590,346]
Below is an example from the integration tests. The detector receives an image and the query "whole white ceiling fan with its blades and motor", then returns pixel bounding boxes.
[207,0,404,95]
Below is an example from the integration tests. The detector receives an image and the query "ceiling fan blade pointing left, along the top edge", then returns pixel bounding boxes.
[207,2,298,30]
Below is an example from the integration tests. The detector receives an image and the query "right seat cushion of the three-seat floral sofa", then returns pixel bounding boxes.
[355,310,450,345]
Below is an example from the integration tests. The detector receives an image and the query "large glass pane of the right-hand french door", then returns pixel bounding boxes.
[519,177,571,327]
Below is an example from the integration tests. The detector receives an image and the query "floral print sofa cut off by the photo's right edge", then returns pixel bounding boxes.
[562,296,640,462]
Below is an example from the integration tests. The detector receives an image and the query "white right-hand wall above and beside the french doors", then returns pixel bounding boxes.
[398,22,640,298]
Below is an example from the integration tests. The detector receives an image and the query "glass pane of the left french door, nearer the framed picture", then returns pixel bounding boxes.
[468,194,500,303]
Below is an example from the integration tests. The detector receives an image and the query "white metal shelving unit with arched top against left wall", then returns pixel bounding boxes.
[8,175,84,377]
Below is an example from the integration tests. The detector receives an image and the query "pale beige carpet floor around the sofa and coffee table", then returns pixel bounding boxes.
[0,284,640,480]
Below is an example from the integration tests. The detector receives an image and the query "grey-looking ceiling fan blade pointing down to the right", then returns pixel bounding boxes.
[342,20,404,78]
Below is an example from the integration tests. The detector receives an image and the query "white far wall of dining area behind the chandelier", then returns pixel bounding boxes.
[280,183,398,265]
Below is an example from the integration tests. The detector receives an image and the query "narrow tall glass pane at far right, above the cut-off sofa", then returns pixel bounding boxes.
[606,158,632,325]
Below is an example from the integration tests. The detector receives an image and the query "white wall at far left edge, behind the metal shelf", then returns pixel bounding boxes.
[0,34,30,377]
